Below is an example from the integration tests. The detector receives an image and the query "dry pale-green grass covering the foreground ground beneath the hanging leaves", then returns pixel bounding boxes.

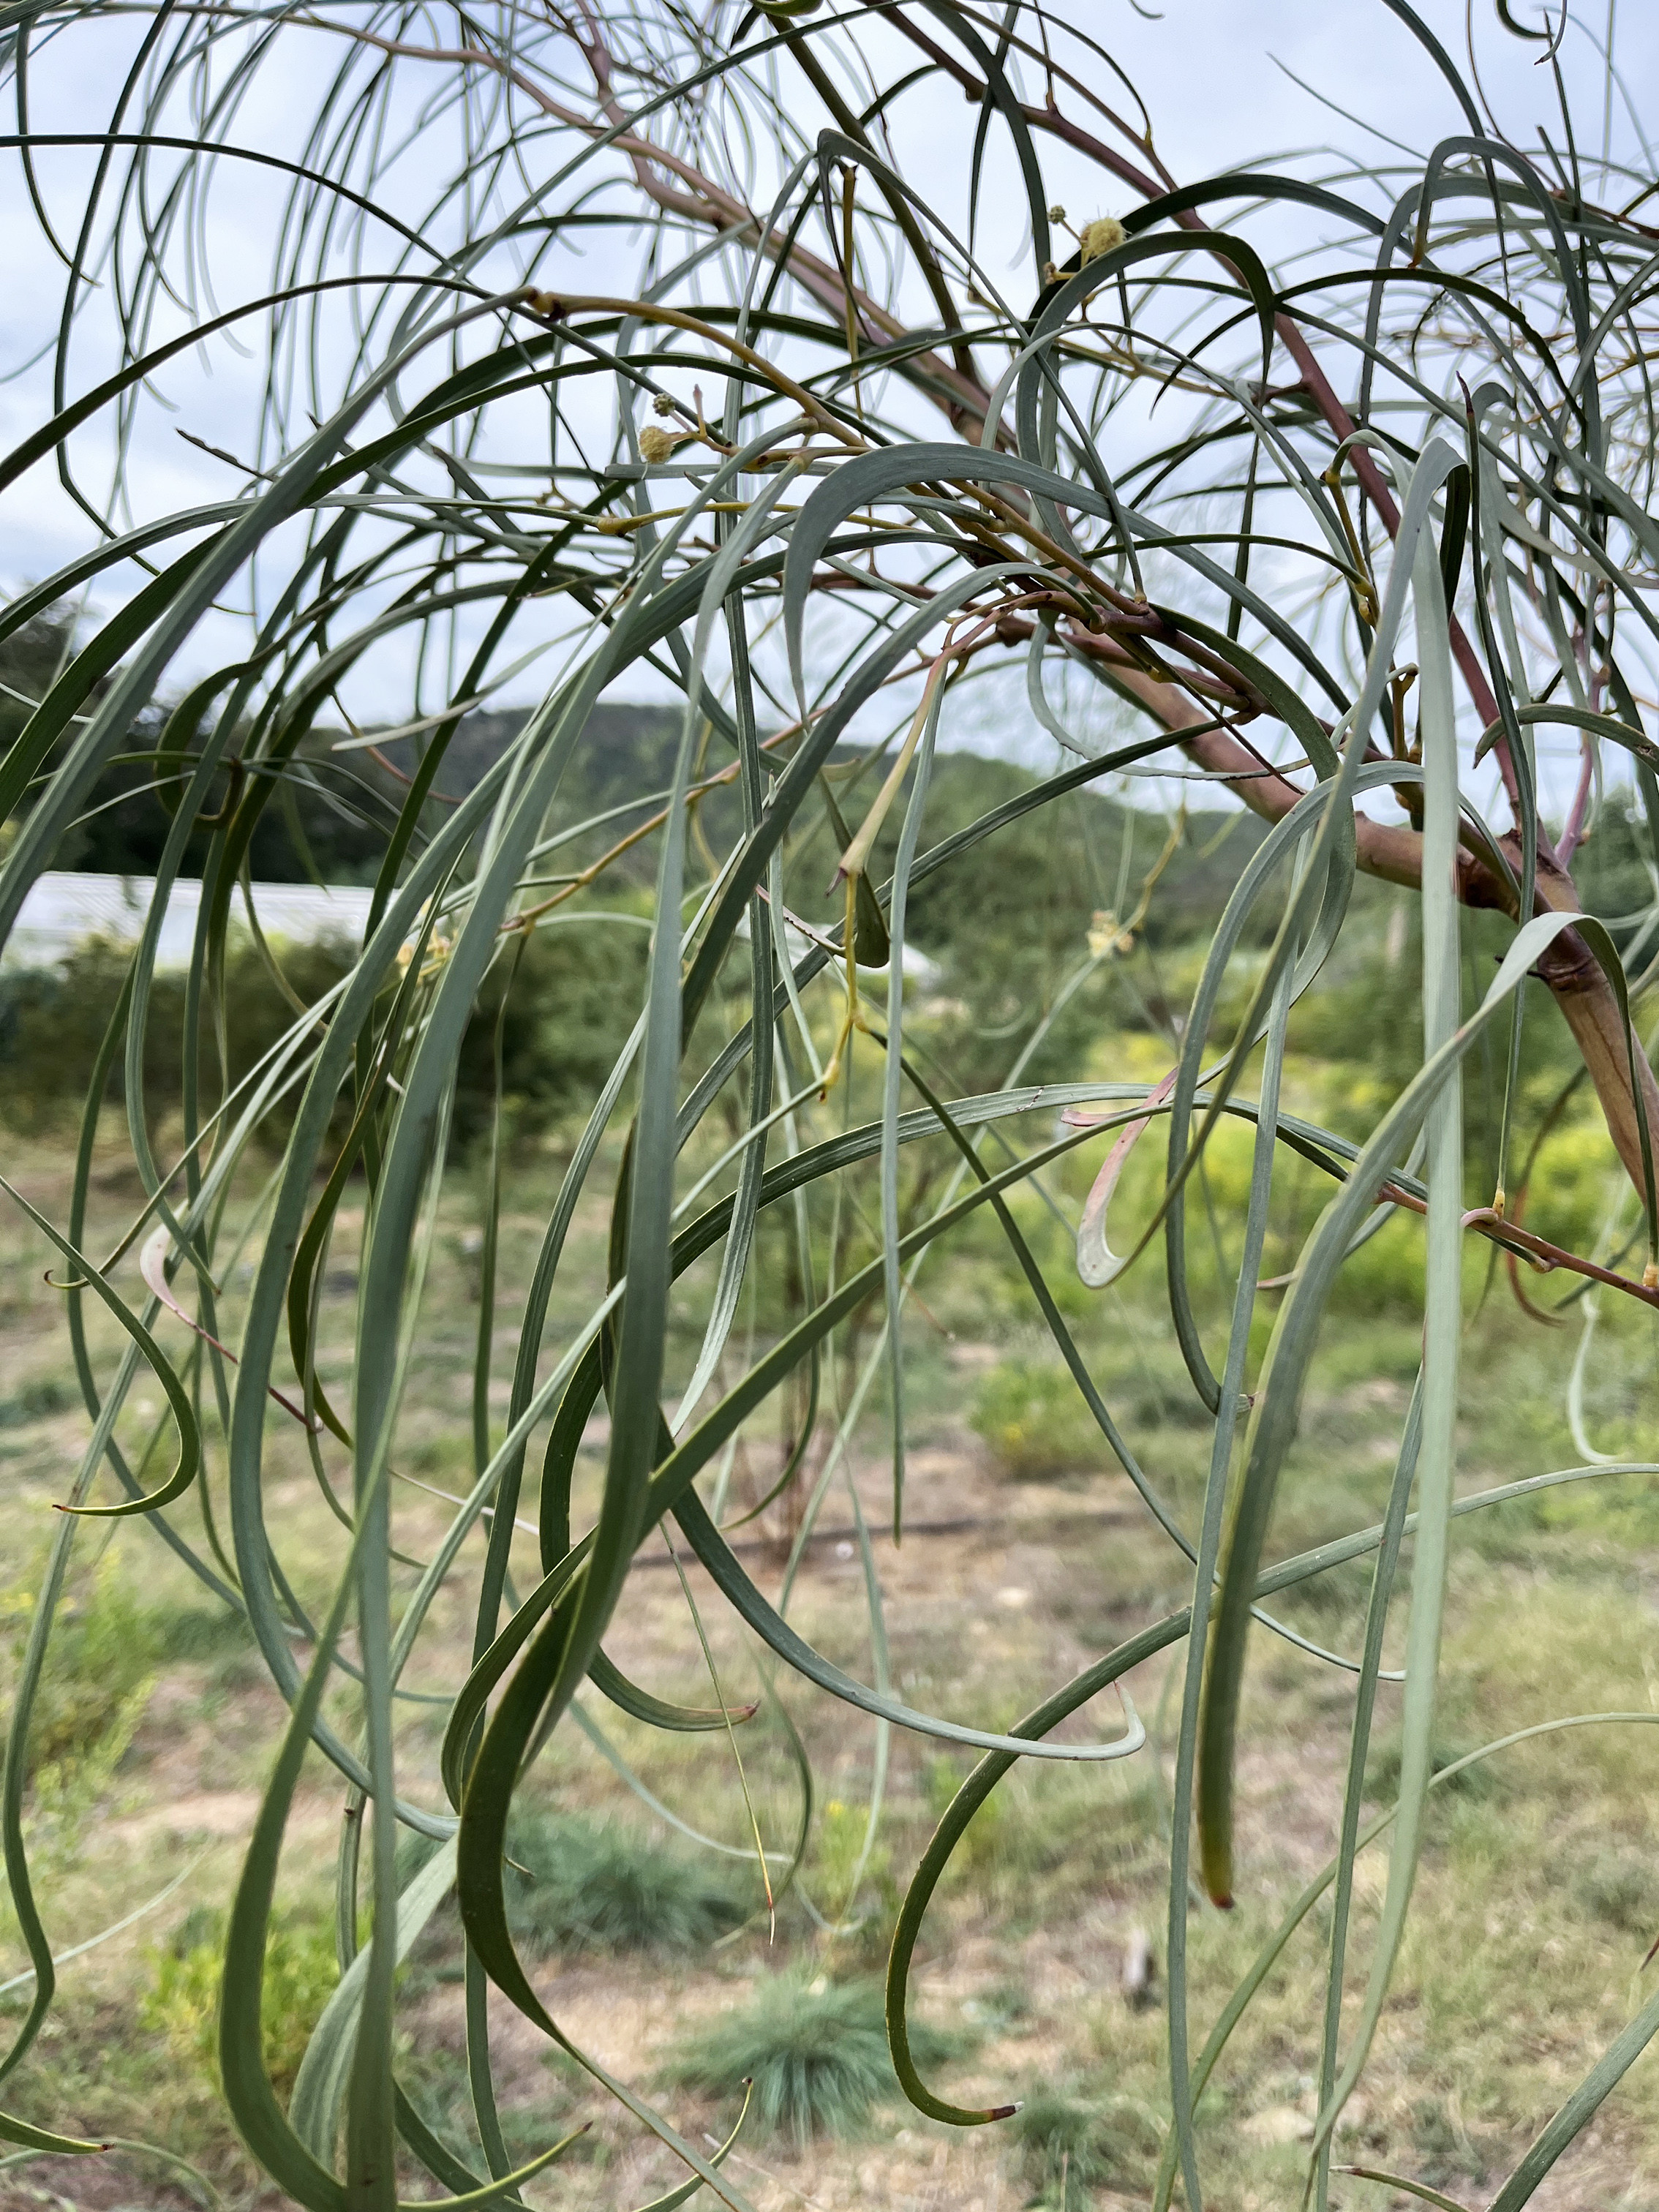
[4,1155,1659,2212]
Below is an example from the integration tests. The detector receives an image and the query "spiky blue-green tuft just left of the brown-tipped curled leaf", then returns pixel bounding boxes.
[666,1973,960,2150]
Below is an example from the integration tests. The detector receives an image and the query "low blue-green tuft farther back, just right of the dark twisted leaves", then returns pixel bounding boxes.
[509,1816,745,1953]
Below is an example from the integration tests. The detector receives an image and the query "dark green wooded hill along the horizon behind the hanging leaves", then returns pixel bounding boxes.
[0,615,1650,1004]
